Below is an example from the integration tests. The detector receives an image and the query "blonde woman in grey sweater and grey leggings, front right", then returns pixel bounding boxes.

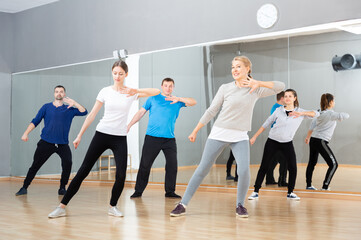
[170,56,285,217]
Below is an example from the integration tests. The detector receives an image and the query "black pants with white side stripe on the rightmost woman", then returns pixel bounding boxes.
[306,137,338,189]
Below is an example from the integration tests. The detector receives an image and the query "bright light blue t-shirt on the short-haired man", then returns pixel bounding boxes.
[143,94,185,138]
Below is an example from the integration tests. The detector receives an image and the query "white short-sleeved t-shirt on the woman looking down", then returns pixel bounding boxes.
[96,86,138,136]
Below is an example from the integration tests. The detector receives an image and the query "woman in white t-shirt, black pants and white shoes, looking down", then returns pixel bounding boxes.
[48,61,160,218]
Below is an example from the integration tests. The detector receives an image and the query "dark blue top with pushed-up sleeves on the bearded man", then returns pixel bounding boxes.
[31,102,88,144]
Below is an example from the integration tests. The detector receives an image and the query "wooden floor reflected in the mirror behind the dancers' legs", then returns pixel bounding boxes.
[30,164,361,193]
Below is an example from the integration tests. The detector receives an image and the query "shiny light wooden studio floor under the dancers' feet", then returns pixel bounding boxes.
[0,179,361,240]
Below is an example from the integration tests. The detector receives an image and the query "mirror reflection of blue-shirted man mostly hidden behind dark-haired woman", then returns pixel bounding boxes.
[266,91,288,187]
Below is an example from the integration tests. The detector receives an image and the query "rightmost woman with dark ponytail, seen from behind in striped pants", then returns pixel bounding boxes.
[305,93,350,190]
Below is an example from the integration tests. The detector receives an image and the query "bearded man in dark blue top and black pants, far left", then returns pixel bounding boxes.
[15,85,88,196]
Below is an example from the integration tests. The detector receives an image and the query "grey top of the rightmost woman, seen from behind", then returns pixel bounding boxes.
[310,109,350,142]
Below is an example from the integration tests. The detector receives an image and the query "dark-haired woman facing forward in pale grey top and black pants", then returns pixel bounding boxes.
[248,89,320,200]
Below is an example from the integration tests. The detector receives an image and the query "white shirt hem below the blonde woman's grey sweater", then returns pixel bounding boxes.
[208,125,249,142]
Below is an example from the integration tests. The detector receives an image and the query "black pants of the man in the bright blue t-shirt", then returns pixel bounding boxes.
[135,135,178,193]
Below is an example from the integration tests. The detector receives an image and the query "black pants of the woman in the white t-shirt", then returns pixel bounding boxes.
[61,132,128,206]
